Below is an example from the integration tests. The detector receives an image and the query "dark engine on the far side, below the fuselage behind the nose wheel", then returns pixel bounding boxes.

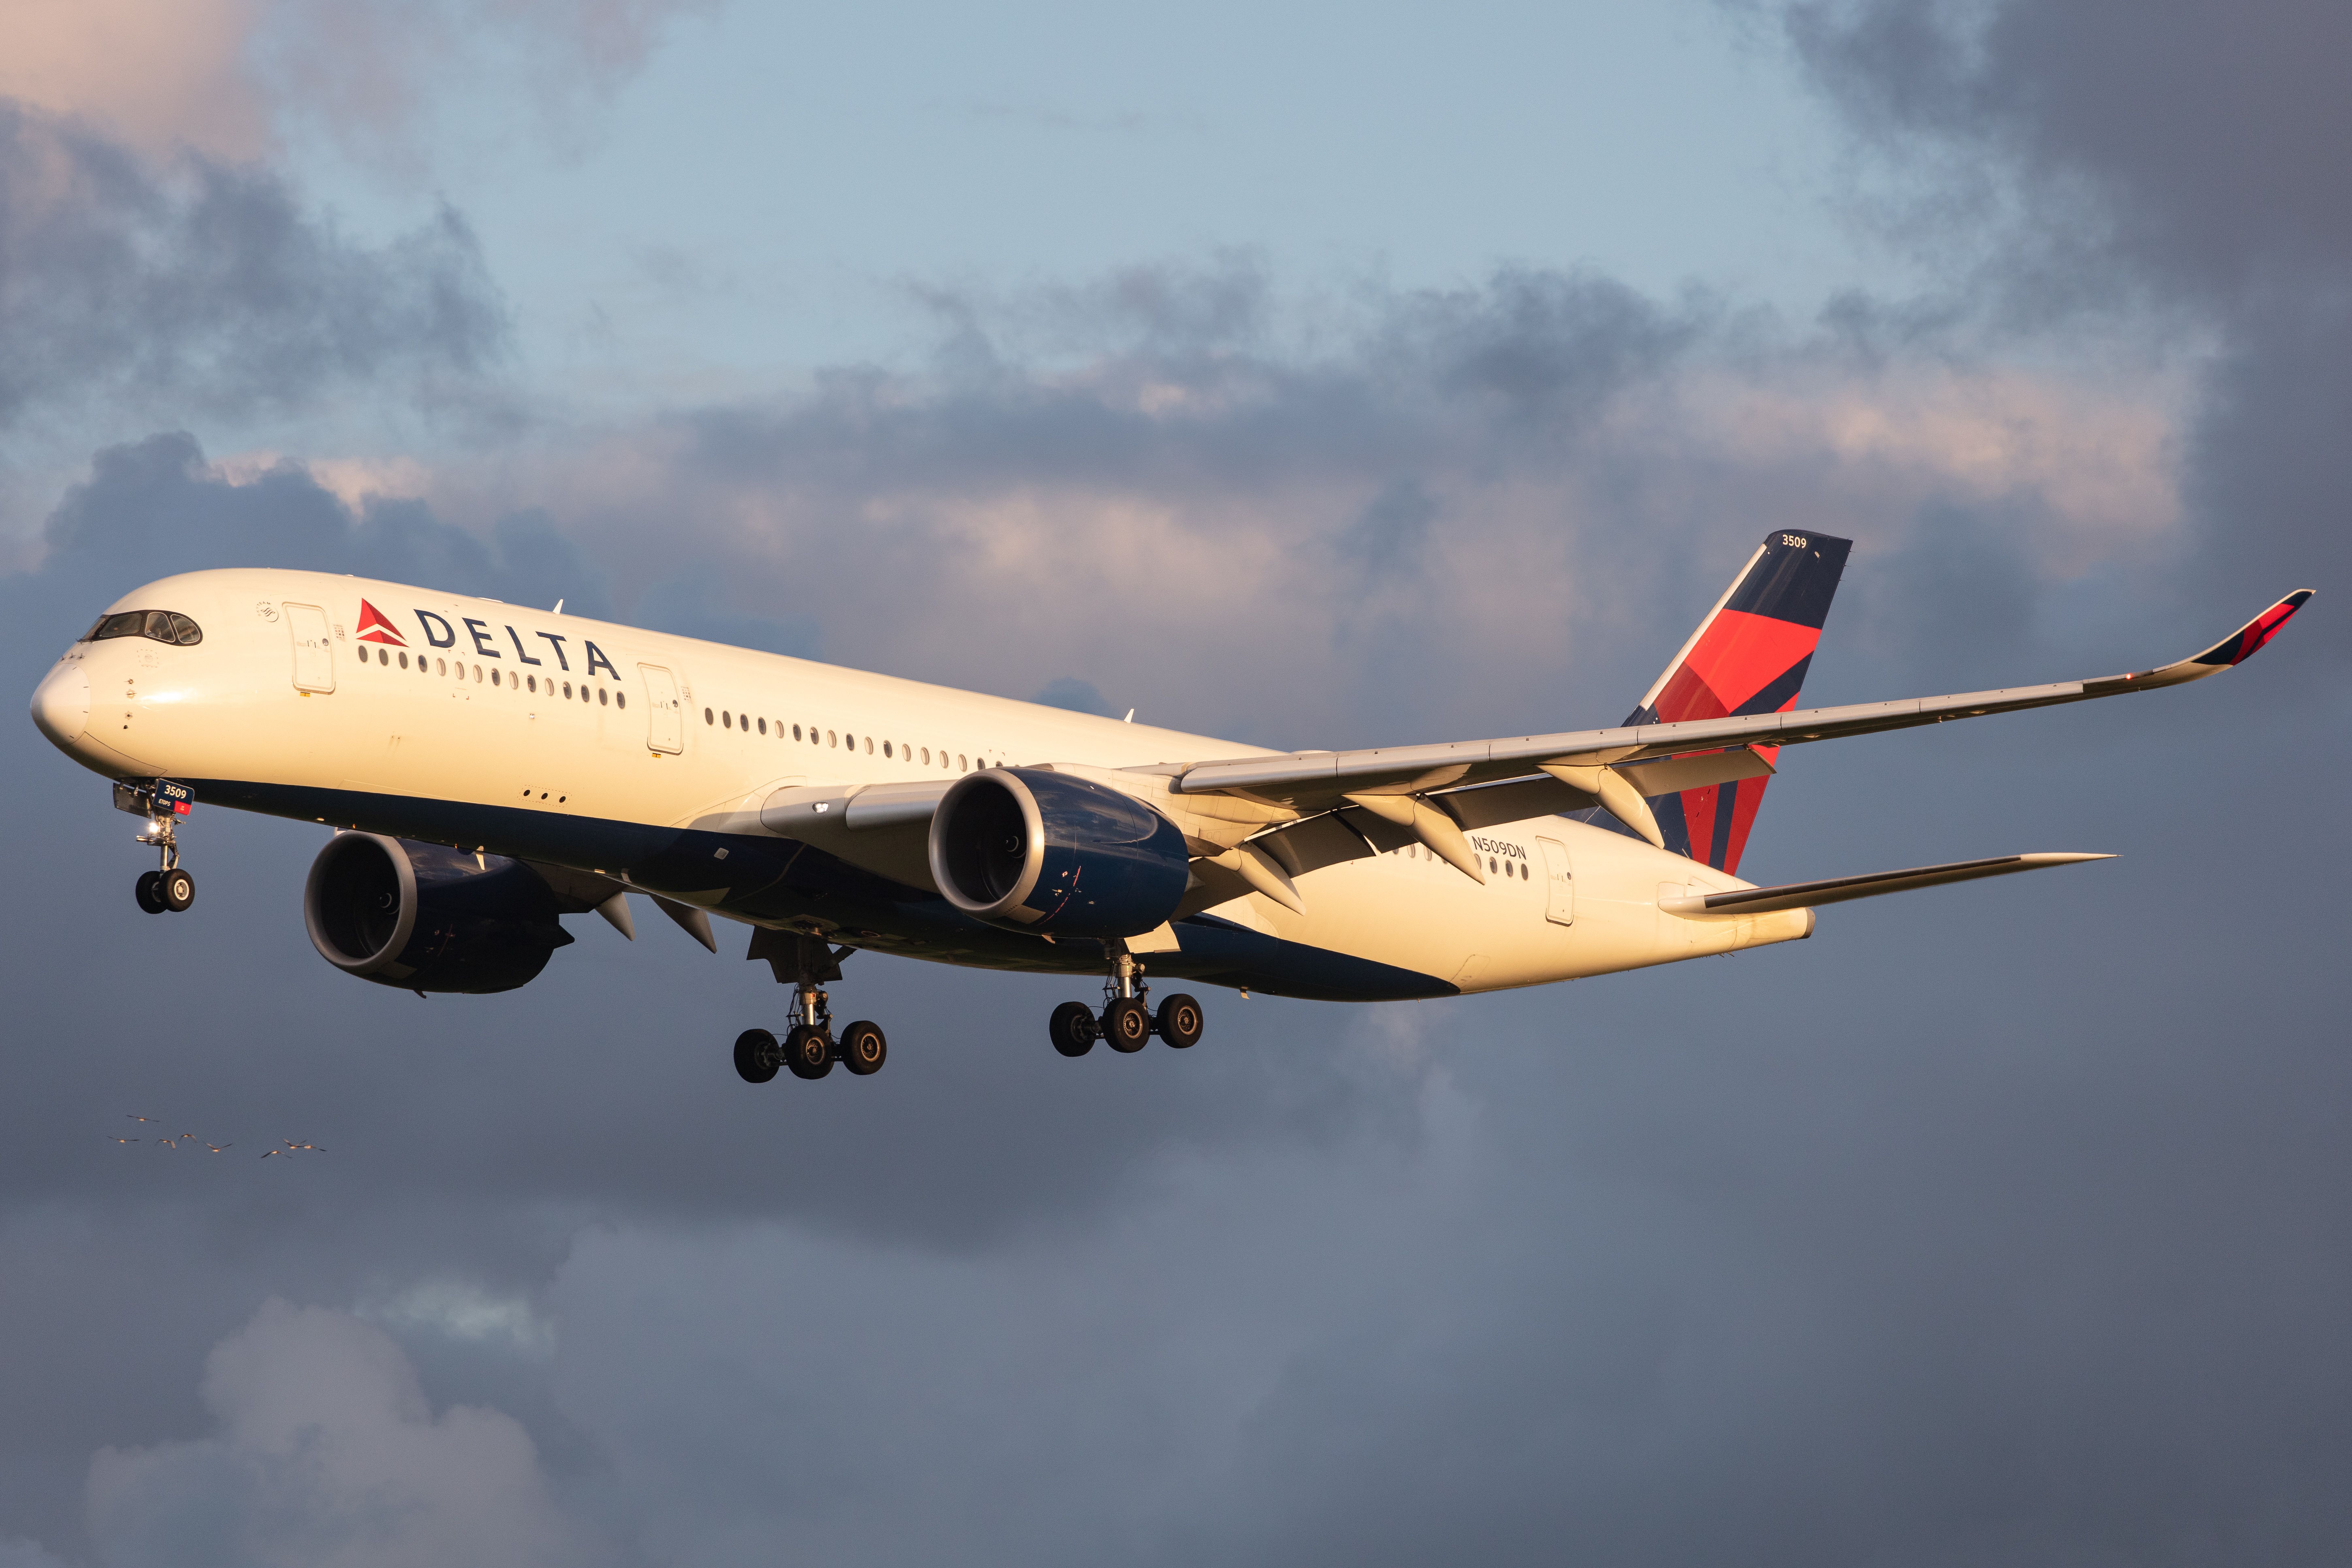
[301,832,572,992]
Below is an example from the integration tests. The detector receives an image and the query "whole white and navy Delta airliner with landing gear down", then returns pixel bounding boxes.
[33,534,2310,1081]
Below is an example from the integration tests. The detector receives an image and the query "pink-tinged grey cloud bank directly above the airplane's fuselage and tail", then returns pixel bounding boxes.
[414,259,2190,745]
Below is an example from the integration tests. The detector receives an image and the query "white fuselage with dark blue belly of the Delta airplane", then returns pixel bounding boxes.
[33,569,1813,997]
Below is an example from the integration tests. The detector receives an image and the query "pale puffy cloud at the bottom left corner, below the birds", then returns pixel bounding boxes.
[89,1300,607,1568]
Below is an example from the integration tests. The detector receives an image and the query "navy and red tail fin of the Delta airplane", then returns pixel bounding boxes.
[1625,531,1853,875]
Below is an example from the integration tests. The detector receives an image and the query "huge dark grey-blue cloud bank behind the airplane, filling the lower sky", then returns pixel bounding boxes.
[0,169,2352,1566]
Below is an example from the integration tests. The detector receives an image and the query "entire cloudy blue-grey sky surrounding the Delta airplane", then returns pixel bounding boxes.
[0,0,2352,1568]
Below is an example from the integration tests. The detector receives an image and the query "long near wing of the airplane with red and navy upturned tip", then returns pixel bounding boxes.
[1171,588,2312,814]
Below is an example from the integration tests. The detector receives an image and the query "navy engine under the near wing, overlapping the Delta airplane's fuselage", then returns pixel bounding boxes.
[931,769,1192,936]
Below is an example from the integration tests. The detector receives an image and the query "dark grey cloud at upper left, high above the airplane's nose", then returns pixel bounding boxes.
[0,99,506,433]
